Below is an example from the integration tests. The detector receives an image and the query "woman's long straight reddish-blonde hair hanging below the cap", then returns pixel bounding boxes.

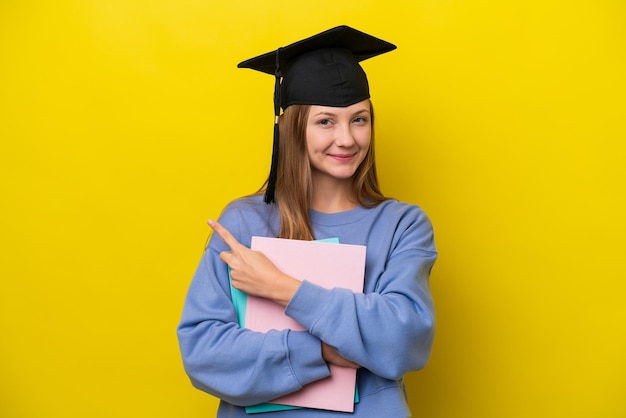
[258,101,388,240]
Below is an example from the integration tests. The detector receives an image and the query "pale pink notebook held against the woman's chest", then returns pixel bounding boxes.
[245,237,366,412]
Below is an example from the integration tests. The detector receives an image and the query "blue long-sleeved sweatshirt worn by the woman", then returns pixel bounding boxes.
[177,196,437,418]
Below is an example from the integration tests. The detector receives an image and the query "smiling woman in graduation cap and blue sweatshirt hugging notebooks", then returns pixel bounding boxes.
[178,26,437,418]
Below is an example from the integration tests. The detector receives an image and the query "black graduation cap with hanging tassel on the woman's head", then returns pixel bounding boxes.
[237,26,396,203]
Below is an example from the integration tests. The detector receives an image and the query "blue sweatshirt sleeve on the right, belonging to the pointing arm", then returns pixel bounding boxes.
[285,208,437,380]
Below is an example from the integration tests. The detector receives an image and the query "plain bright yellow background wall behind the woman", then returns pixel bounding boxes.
[0,0,626,418]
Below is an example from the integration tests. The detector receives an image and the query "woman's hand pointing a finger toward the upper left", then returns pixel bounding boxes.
[208,220,300,306]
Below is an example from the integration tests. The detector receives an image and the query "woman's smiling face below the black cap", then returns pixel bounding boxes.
[306,100,372,185]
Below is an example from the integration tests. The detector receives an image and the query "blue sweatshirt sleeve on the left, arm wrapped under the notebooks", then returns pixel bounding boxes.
[177,209,330,406]
